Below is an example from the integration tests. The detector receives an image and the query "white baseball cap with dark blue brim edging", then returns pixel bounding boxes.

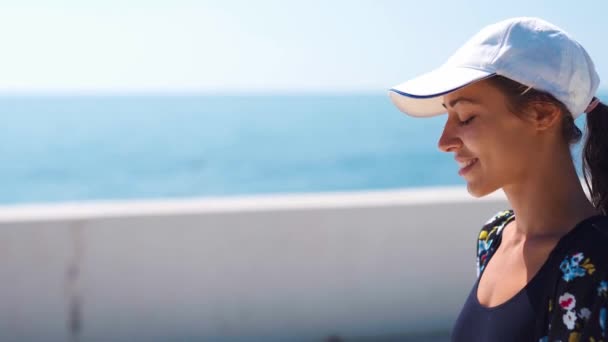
[389,17,600,119]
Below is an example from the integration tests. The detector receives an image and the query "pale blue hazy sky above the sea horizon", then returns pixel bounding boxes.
[0,0,608,94]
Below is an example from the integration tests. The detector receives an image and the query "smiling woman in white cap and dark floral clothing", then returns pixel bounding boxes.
[389,18,608,342]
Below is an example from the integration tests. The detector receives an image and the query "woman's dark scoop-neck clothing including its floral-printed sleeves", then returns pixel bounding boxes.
[451,210,608,342]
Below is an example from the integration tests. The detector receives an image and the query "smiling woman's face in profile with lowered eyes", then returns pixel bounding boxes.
[438,81,538,197]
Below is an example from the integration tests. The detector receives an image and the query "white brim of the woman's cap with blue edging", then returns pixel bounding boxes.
[389,67,495,117]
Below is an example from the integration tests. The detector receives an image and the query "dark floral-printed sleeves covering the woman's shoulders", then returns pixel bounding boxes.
[476,209,608,342]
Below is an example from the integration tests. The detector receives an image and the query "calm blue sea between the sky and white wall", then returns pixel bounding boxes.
[0,93,596,204]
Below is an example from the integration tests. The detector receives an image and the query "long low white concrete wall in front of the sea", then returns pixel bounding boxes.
[0,188,508,342]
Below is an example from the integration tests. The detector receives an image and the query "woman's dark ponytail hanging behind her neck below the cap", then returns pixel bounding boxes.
[582,102,608,215]
